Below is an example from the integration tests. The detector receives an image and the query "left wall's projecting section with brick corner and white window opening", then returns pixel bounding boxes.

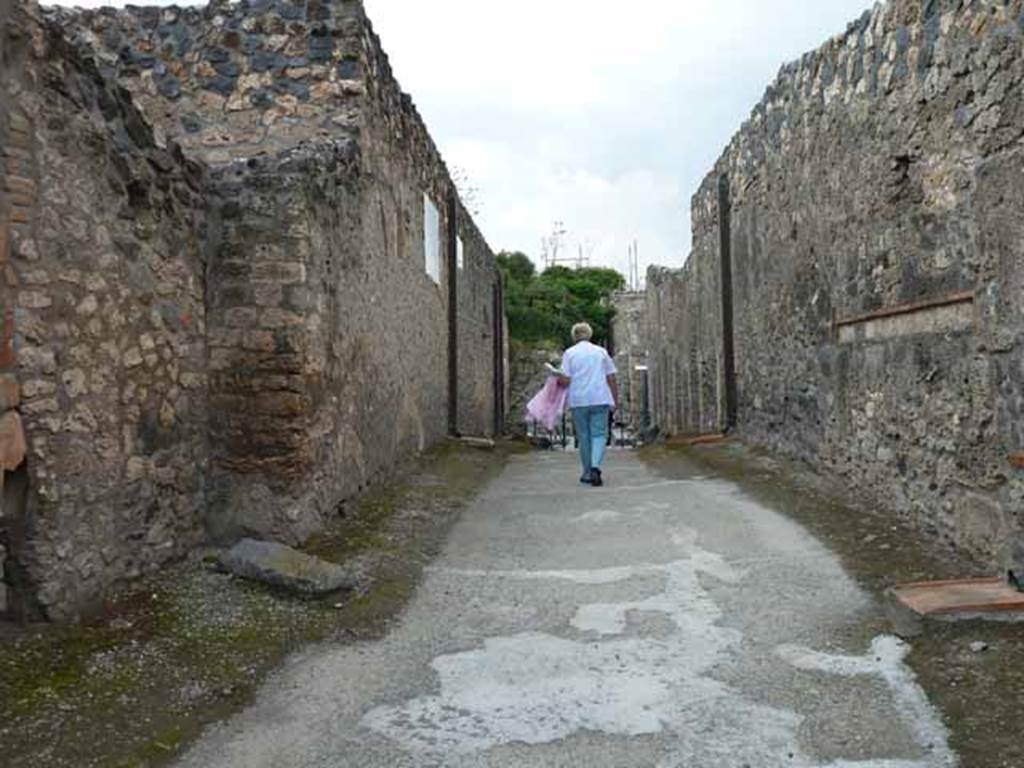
[198,3,499,541]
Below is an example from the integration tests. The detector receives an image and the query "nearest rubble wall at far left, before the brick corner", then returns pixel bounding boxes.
[2,5,206,617]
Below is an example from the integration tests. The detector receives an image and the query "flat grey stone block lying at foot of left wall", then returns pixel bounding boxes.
[220,539,359,596]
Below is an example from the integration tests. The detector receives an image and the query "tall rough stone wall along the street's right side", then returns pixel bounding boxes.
[647,0,1024,564]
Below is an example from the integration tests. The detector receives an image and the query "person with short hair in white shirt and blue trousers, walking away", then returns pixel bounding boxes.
[560,323,618,486]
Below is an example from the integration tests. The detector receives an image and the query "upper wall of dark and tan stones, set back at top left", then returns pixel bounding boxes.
[48,0,366,165]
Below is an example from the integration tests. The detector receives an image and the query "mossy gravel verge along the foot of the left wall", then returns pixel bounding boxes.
[0,444,513,768]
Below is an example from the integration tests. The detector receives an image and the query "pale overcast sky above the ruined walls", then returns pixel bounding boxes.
[51,0,870,282]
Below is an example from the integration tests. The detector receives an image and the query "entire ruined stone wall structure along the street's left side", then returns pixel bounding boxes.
[0,0,501,617]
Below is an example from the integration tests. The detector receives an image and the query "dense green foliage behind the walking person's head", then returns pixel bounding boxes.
[498,252,626,347]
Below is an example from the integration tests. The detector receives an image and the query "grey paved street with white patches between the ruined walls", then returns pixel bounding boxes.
[179,453,956,768]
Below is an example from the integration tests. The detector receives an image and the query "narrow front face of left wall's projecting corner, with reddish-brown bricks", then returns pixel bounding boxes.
[201,141,367,543]
